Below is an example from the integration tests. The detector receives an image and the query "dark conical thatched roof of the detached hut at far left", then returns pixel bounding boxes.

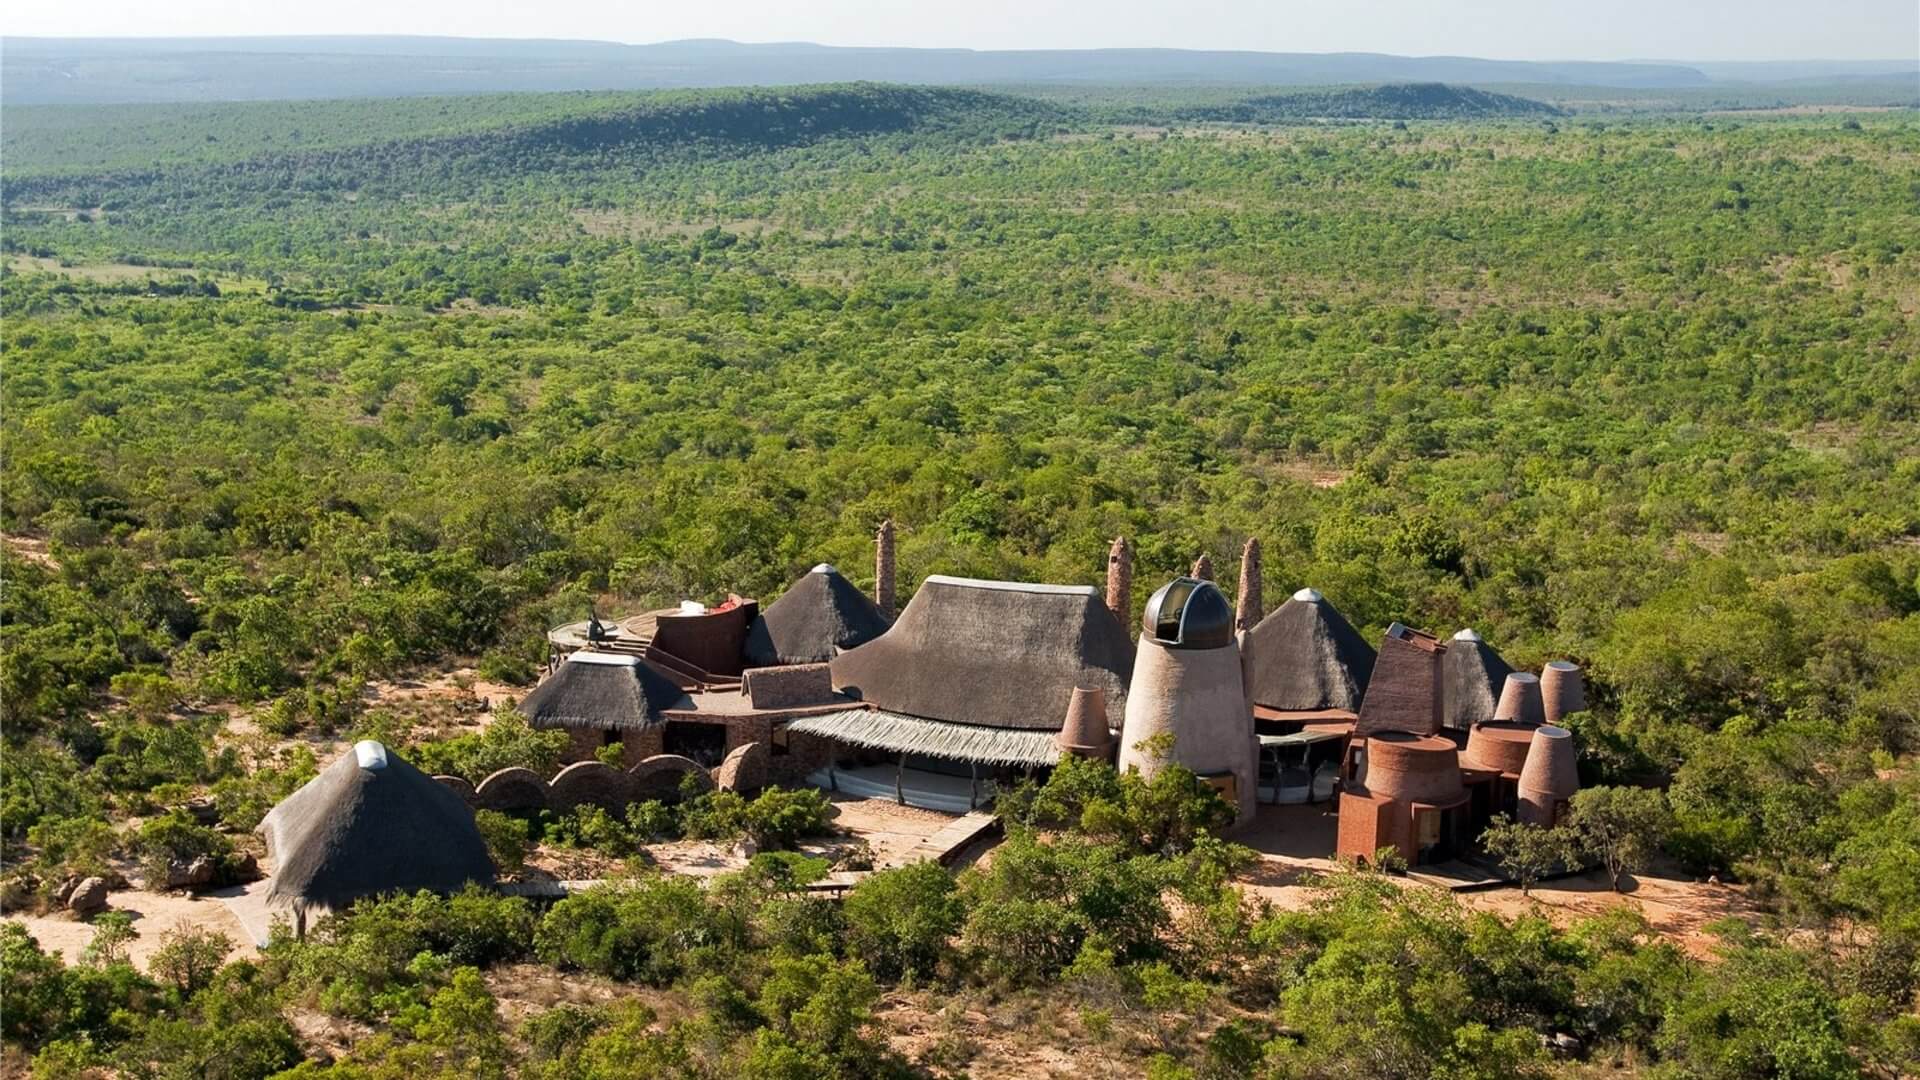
[259,740,493,913]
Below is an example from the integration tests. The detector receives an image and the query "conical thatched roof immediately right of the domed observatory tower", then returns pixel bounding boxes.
[1246,588,1375,713]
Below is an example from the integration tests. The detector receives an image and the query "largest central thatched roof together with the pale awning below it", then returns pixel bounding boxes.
[789,575,1133,767]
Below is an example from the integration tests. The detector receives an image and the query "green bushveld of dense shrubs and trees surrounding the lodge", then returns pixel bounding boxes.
[0,86,1920,1076]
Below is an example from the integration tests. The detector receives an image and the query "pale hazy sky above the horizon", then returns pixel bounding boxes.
[0,0,1920,60]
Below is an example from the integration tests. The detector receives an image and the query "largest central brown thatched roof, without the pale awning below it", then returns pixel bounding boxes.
[833,575,1133,734]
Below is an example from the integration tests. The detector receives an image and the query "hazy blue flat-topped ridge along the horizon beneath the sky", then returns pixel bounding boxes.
[0,37,1743,106]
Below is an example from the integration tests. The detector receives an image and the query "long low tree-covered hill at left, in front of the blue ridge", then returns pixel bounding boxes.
[4,83,1079,195]
